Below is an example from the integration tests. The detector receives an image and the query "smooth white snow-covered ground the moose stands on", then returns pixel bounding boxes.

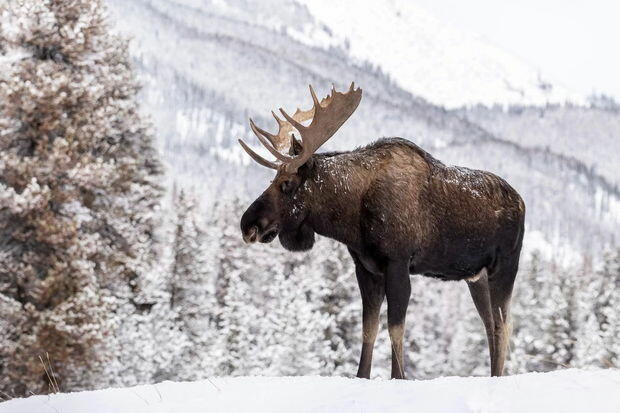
[0,369,620,413]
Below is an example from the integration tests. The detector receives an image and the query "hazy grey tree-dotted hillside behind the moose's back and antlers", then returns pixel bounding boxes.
[111,0,620,251]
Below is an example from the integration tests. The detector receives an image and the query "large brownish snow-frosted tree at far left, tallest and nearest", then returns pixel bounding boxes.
[0,0,160,395]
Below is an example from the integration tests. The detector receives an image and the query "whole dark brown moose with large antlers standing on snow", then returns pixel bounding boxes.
[239,83,525,379]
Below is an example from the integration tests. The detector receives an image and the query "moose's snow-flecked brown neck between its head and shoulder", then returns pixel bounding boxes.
[305,152,365,248]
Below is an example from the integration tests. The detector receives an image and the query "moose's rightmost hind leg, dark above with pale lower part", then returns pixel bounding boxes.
[489,261,518,376]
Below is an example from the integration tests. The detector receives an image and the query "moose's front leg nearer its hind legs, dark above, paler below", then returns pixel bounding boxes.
[385,260,411,379]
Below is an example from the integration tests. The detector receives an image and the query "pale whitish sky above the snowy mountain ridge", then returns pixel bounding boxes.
[412,0,620,101]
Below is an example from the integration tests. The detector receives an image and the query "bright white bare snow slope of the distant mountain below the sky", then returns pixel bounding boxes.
[300,0,582,107]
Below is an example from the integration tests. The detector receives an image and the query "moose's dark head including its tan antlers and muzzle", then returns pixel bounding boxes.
[239,83,362,251]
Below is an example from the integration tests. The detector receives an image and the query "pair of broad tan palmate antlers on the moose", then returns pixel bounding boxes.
[239,83,362,173]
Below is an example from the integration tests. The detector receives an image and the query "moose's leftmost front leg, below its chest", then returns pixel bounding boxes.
[351,253,385,379]
